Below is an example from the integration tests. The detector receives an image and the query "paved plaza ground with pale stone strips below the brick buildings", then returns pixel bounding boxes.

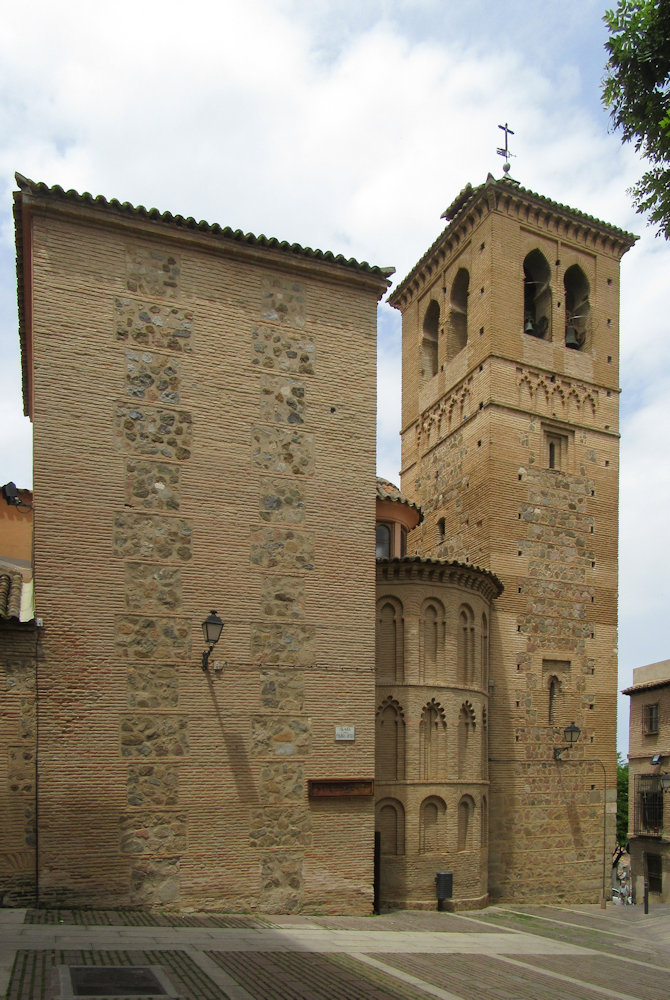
[0,904,670,1000]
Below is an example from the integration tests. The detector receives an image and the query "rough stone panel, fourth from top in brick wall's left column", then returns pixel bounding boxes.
[114,403,193,462]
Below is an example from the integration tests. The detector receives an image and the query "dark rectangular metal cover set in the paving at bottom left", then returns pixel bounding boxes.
[58,965,178,1000]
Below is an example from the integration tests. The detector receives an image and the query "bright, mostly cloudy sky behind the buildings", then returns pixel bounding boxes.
[0,0,670,751]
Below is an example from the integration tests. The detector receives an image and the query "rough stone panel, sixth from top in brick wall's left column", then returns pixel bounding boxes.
[112,511,193,562]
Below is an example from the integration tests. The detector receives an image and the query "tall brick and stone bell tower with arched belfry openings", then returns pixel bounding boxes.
[390,168,635,902]
